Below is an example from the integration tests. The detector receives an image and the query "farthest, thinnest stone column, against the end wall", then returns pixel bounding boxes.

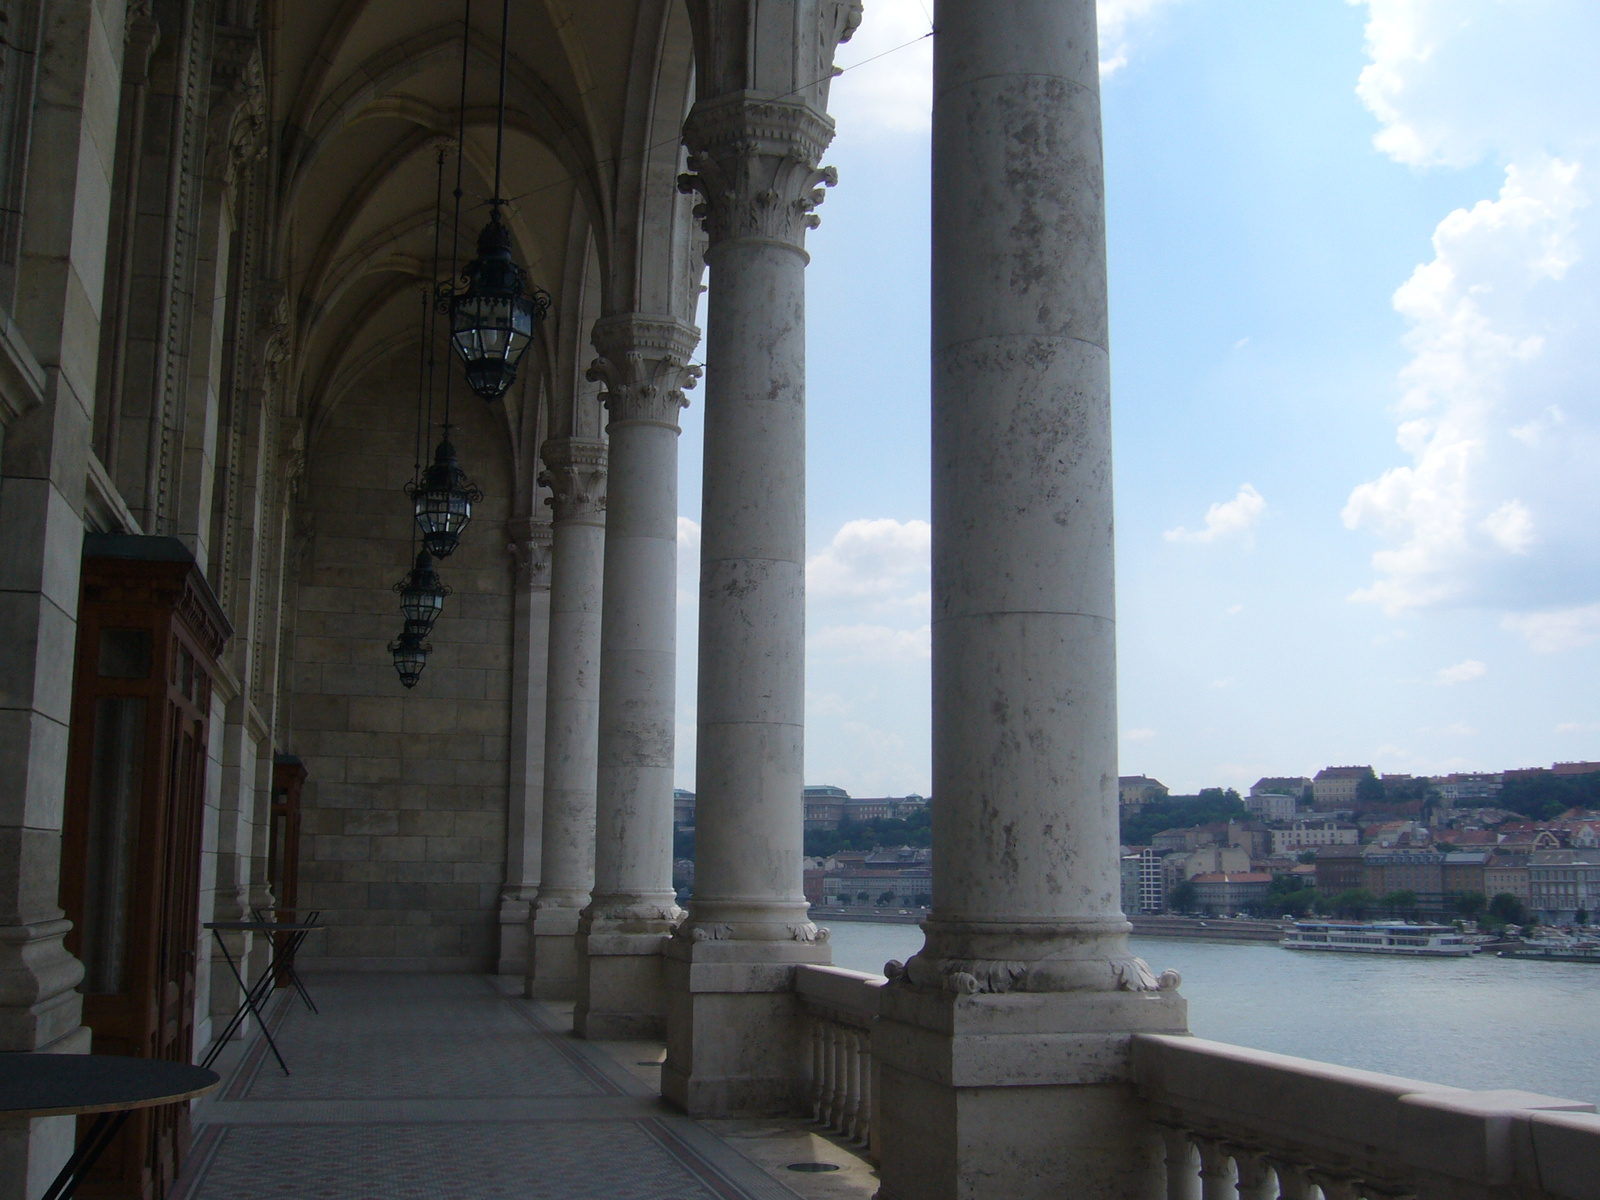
[498,517,552,976]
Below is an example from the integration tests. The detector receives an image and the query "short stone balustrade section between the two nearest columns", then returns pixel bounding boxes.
[795,966,888,1158]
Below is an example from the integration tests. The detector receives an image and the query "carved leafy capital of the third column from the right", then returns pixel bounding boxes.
[586,312,701,432]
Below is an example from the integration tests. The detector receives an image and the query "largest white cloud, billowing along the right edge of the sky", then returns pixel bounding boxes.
[1342,0,1600,630]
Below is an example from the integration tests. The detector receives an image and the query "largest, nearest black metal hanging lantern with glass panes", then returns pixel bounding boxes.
[450,205,550,400]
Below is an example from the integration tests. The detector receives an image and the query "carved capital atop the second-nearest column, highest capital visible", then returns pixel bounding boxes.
[678,99,838,253]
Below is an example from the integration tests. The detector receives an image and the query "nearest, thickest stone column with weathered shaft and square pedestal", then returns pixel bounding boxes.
[874,9,1184,1200]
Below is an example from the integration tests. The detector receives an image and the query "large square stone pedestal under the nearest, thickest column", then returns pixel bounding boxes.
[872,981,1187,1200]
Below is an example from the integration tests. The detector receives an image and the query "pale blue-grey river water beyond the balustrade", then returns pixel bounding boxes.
[822,920,1600,1104]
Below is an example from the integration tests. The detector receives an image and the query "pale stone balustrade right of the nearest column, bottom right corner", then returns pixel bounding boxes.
[1133,1035,1600,1200]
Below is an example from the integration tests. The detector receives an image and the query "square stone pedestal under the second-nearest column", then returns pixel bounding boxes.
[661,925,834,1117]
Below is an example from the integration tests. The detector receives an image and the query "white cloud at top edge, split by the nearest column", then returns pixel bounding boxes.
[827,0,1178,134]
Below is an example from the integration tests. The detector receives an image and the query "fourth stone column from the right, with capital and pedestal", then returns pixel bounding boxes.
[526,437,606,1000]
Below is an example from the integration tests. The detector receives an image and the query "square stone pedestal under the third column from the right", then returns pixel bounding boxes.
[573,920,672,1042]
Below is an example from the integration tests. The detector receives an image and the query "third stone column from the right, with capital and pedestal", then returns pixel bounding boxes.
[573,314,699,1038]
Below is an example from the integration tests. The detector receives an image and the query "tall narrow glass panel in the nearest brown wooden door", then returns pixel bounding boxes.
[80,694,146,995]
